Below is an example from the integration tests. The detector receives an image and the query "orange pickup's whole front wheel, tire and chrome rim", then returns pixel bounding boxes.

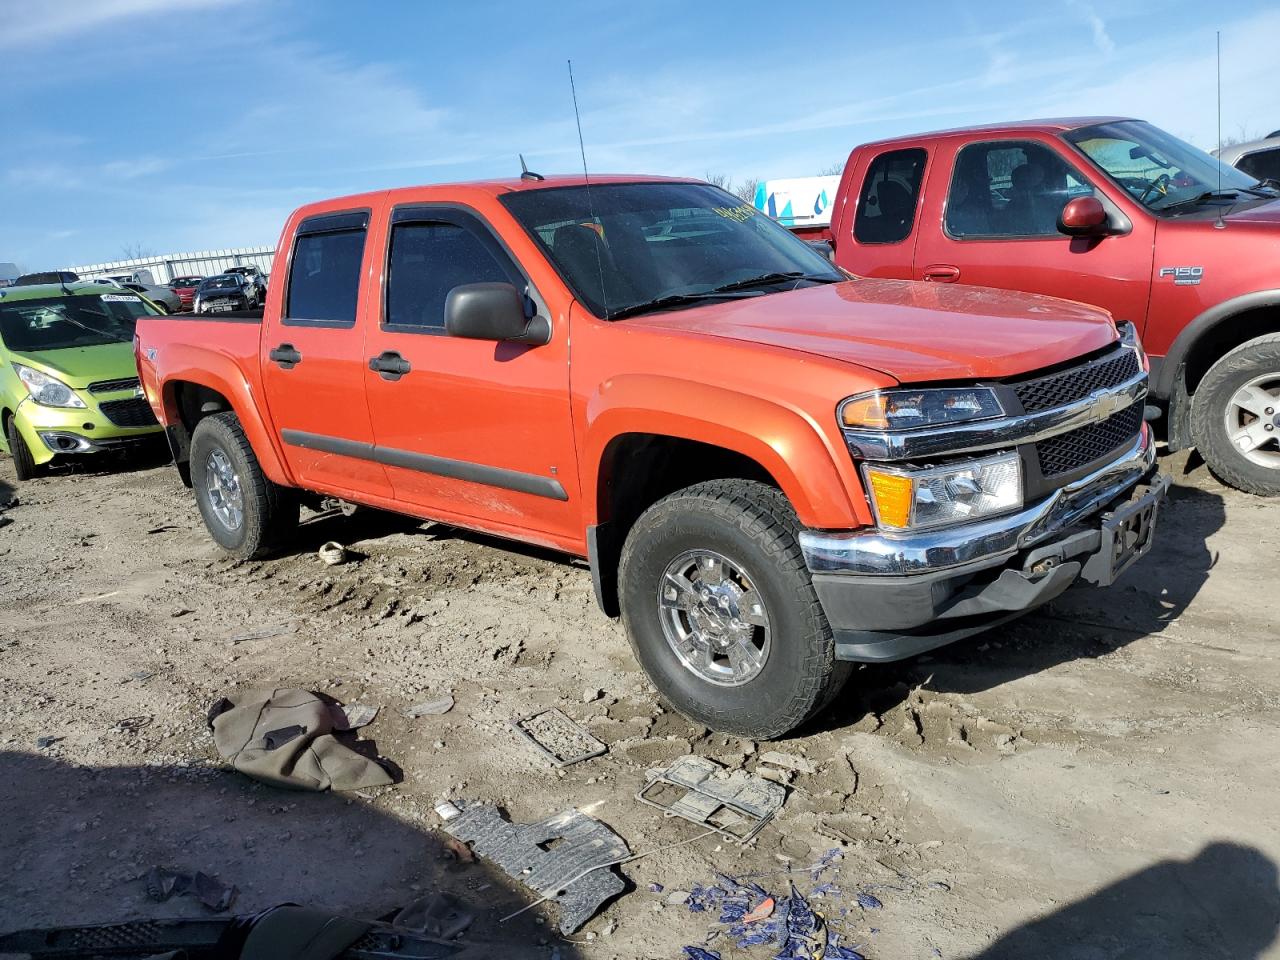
[618,480,849,740]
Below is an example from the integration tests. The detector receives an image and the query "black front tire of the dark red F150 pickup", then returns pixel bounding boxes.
[1190,334,1280,497]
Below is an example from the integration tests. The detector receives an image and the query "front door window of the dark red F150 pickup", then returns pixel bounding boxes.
[946,141,1093,239]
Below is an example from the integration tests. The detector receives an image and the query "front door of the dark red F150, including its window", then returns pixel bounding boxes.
[915,138,1155,329]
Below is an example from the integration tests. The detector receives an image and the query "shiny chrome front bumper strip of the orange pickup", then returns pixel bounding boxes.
[800,426,1156,577]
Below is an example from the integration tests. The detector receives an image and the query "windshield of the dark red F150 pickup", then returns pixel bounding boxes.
[1065,120,1272,212]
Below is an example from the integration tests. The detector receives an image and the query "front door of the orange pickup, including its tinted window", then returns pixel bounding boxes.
[364,204,582,543]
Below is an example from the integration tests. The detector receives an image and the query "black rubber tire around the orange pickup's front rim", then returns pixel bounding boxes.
[618,480,851,740]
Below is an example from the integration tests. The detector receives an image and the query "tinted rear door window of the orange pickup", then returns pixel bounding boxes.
[284,214,369,326]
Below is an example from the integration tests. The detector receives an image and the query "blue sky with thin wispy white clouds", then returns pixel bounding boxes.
[0,0,1280,269]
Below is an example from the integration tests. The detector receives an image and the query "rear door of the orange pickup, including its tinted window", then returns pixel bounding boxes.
[260,210,392,497]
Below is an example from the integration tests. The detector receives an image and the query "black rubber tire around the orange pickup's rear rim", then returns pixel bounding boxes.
[191,413,298,559]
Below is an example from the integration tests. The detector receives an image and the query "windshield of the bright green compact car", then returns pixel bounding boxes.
[0,293,156,353]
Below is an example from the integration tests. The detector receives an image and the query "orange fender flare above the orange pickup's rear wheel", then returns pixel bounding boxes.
[156,343,294,486]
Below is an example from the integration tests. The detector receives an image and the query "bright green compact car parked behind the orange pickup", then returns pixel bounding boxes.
[0,283,161,480]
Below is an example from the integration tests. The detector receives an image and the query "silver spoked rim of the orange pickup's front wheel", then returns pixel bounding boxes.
[658,550,771,686]
